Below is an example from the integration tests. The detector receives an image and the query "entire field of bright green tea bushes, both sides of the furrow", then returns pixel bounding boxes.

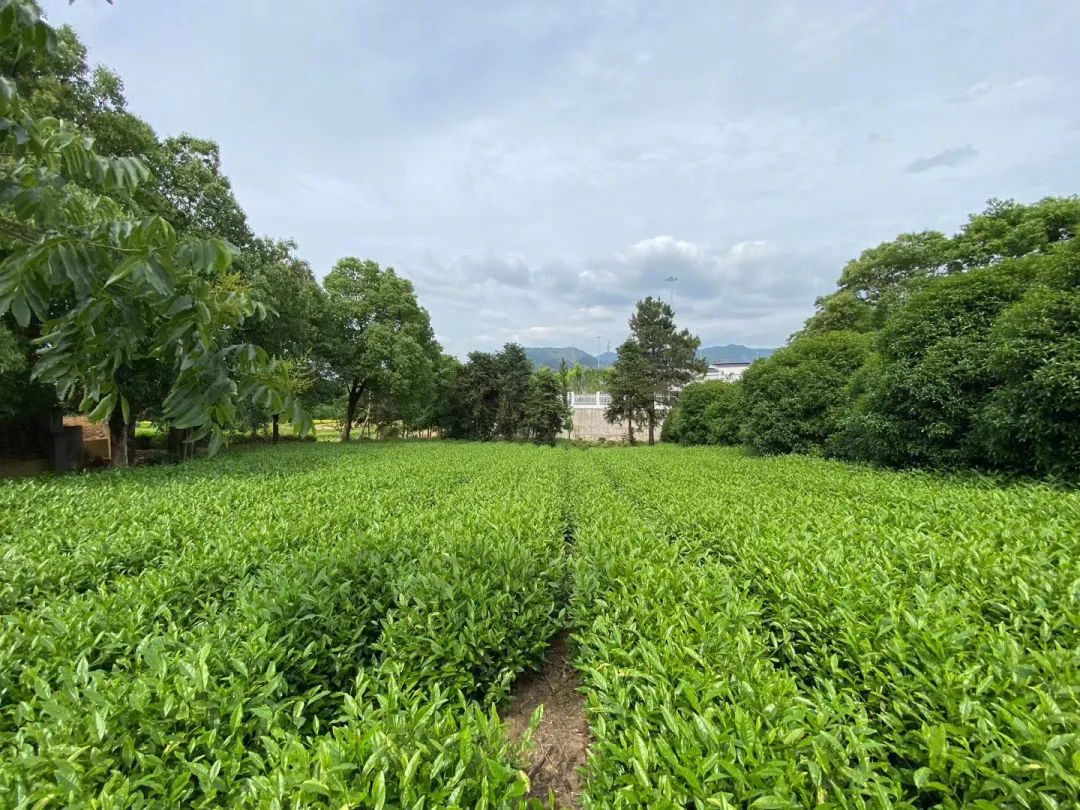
[0,442,1080,810]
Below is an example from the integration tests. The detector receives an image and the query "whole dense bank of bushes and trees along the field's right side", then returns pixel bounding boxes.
[663,198,1080,477]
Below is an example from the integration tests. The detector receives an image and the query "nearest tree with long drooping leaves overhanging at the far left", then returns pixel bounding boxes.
[0,1,308,464]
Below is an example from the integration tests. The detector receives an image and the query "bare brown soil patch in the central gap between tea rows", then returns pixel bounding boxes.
[502,630,589,810]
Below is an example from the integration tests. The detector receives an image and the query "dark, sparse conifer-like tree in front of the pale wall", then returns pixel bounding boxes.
[630,296,707,444]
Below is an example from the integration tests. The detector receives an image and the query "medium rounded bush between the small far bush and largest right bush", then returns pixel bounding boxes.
[741,332,874,454]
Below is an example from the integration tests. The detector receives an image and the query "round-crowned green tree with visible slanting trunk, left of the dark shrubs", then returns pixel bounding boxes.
[321,257,438,442]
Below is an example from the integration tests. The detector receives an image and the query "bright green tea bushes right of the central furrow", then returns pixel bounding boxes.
[568,447,1080,808]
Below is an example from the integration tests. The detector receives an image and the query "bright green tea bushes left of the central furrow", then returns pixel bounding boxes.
[0,443,566,808]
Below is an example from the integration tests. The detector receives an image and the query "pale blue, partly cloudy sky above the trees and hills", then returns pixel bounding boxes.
[43,0,1080,355]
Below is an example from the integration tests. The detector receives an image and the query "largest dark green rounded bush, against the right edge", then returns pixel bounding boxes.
[851,241,1080,474]
